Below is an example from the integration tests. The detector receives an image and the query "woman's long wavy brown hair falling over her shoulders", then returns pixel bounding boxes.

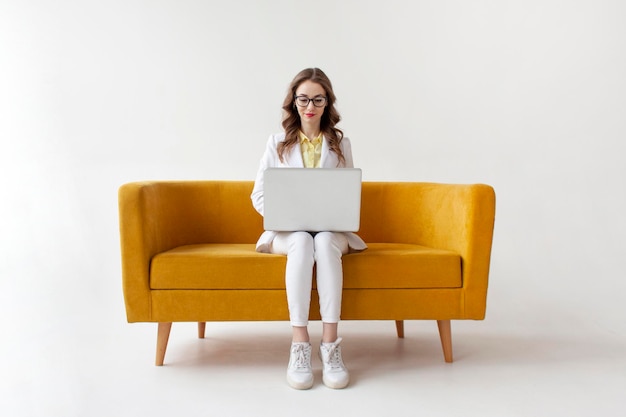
[277,68,346,165]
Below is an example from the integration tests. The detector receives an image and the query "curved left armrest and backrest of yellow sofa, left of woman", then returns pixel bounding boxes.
[118,181,262,322]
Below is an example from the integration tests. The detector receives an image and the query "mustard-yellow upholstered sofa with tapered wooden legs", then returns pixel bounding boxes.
[119,181,495,365]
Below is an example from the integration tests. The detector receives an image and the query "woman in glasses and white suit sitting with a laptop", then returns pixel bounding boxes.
[251,68,367,389]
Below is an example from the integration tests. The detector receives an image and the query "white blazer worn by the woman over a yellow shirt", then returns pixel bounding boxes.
[250,132,367,253]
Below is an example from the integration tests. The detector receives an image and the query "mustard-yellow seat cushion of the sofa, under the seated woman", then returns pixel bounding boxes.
[150,243,461,290]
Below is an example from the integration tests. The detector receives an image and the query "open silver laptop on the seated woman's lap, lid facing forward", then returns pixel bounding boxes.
[263,168,361,232]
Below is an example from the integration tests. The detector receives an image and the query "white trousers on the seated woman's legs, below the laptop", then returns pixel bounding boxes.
[271,232,348,326]
